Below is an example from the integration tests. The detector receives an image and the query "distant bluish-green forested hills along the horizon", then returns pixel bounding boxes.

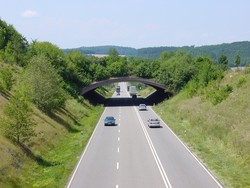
[63,41,250,66]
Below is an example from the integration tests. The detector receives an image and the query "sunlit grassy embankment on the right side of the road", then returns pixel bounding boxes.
[155,71,250,188]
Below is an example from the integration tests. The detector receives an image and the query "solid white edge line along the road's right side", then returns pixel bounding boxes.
[150,107,223,188]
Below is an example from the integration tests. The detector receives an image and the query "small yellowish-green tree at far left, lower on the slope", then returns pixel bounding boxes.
[2,83,35,144]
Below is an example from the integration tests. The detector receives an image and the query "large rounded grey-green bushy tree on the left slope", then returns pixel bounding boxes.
[22,55,66,112]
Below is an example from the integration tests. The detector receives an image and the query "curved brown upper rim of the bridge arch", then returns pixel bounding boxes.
[80,77,170,95]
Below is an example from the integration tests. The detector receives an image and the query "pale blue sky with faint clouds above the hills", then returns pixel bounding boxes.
[0,0,250,48]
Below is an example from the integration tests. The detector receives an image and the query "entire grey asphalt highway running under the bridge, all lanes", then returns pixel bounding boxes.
[66,83,222,188]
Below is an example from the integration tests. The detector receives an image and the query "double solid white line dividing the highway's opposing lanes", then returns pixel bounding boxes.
[134,106,172,188]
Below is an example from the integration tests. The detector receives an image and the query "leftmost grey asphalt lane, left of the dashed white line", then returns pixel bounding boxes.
[68,106,118,188]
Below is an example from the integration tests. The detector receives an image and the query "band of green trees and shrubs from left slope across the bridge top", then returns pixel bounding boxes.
[0,20,237,144]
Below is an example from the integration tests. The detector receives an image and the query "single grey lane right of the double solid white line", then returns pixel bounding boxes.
[140,108,222,188]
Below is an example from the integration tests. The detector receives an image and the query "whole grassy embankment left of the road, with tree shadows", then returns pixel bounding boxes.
[0,95,103,187]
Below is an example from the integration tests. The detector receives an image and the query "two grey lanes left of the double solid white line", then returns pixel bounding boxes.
[67,83,165,188]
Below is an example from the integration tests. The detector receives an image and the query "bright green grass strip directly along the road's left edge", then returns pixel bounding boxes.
[25,107,102,187]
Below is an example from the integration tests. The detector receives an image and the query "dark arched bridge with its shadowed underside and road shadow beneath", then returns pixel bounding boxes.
[80,77,174,106]
